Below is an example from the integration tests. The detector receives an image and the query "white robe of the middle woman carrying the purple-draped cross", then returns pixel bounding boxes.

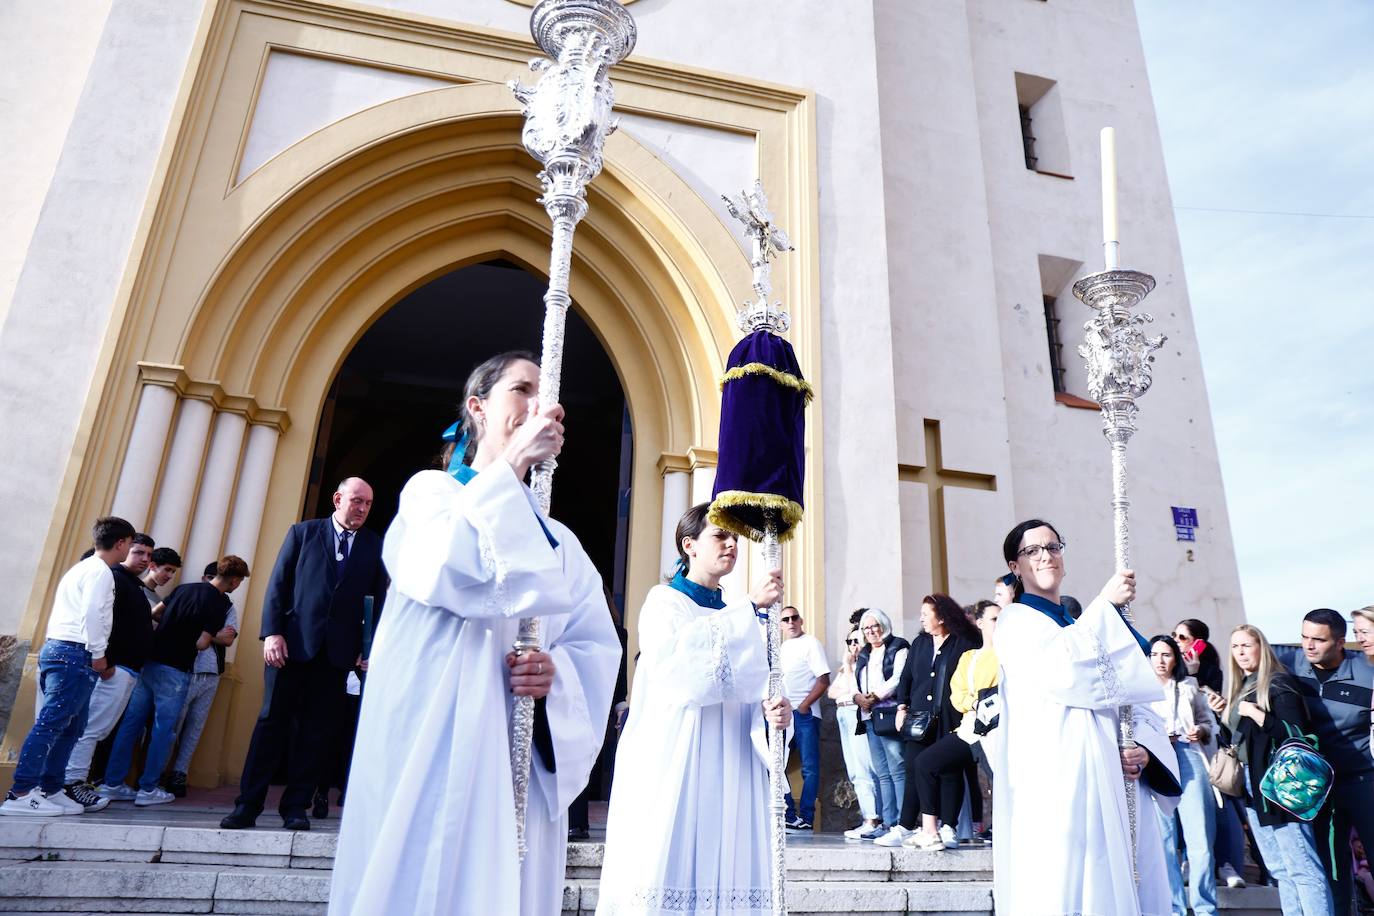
[596,585,772,916]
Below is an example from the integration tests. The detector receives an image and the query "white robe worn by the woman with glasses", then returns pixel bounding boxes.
[985,599,1178,916]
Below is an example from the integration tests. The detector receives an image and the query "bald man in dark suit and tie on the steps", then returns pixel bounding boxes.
[220,477,386,829]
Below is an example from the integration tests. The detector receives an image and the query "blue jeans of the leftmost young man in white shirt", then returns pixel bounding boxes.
[14,640,100,795]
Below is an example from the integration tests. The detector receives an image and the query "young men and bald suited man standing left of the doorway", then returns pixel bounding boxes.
[0,478,386,829]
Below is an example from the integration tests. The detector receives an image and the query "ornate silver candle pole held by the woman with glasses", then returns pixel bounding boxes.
[1073,263,1165,884]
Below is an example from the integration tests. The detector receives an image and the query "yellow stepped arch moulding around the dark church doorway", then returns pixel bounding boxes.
[5,70,819,783]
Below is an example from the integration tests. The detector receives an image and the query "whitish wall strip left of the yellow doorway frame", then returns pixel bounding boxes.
[0,0,202,633]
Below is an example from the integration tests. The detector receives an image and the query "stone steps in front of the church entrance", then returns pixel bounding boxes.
[0,809,1278,916]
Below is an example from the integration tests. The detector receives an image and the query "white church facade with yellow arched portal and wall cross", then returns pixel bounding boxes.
[0,0,1243,784]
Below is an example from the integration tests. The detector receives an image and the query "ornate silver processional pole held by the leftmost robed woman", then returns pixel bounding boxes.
[507,0,636,861]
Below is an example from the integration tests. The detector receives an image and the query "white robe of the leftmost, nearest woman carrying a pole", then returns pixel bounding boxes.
[330,461,621,916]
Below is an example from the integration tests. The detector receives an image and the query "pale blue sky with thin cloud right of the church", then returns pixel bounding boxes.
[1136,0,1374,641]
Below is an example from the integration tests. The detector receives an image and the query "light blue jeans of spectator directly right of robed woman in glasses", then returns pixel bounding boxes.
[1160,742,1216,916]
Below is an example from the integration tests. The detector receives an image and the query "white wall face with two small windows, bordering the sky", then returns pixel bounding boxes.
[969,0,1242,633]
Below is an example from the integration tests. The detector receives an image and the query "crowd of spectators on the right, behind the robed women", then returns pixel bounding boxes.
[793,577,1374,916]
